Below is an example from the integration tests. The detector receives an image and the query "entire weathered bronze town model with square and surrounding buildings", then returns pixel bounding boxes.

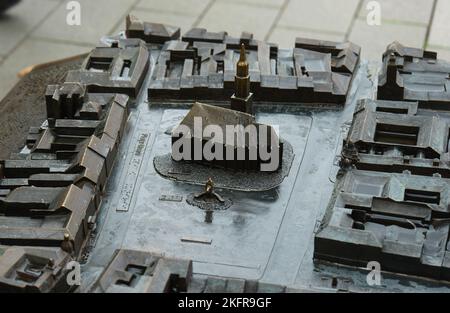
[0,17,450,292]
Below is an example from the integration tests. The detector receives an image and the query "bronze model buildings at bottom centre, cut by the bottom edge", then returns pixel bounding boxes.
[91,250,295,293]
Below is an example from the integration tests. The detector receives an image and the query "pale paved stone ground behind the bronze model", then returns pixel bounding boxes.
[0,0,450,99]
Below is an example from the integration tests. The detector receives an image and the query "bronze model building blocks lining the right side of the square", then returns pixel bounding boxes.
[314,43,450,281]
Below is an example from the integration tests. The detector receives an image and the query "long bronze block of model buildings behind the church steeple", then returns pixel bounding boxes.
[142,13,361,105]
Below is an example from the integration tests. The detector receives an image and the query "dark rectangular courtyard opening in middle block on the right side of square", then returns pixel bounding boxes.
[374,124,419,146]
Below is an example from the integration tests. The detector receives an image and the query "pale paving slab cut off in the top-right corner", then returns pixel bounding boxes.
[428,0,450,49]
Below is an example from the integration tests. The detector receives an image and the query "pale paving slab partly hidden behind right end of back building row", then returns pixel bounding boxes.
[268,27,345,49]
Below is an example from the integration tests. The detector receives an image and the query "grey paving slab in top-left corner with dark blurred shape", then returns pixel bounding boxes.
[0,0,59,55]
